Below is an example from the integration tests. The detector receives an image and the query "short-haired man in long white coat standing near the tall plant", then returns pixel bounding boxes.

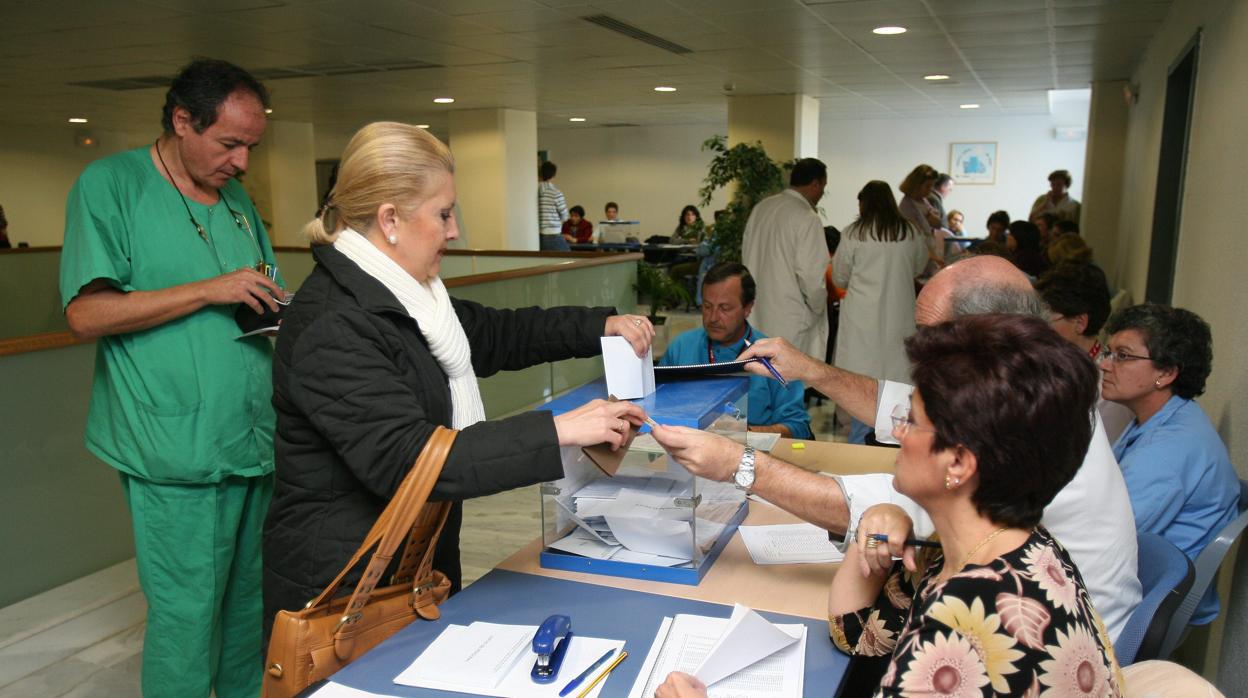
[741,157,827,356]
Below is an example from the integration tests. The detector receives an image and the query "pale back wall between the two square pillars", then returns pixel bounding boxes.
[533,125,728,237]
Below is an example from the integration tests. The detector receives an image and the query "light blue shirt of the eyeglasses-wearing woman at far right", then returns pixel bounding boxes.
[1113,396,1239,624]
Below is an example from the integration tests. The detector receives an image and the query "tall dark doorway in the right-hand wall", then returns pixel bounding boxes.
[1144,31,1201,305]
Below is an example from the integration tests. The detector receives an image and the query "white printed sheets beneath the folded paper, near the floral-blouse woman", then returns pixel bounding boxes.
[629,616,806,698]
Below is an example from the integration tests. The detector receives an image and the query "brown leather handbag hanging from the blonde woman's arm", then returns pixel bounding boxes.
[262,427,458,698]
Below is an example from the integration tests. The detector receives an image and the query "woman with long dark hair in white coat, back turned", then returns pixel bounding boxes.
[832,180,927,443]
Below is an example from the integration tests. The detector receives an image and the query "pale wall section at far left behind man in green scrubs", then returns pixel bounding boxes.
[0,126,148,247]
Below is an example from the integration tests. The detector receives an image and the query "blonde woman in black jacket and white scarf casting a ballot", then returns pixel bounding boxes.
[263,122,654,631]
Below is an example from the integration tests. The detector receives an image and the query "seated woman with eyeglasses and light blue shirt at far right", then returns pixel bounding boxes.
[1101,303,1239,624]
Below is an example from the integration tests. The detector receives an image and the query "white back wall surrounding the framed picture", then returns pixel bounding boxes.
[819,112,1087,235]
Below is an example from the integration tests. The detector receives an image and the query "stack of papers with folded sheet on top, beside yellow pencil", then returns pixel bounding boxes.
[629,604,806,698]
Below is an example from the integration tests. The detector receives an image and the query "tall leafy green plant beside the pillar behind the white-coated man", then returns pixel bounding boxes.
[698,136,784,262]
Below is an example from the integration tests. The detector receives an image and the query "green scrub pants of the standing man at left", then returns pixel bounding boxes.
[121,474,273,698]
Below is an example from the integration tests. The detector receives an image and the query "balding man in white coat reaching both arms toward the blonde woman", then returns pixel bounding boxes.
[654,256,1141,639]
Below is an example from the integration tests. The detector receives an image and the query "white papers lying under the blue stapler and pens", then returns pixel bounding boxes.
[394,622,624,698]
